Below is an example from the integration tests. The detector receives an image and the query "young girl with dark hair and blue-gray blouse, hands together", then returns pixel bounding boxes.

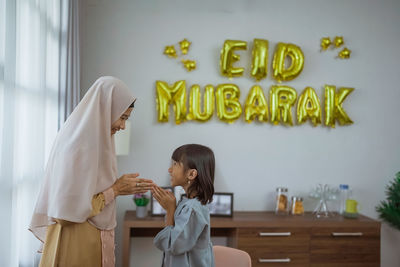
[152,144,215,267]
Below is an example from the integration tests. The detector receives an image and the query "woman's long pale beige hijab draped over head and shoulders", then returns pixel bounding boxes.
[29,77,135,242]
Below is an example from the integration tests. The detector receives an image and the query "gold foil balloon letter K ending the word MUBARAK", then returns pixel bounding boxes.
[325,85,354,128]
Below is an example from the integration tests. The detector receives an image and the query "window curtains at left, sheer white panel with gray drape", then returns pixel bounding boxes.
[0,0,79,267]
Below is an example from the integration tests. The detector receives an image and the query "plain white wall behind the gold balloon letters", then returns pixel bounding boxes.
[82,0,400,266]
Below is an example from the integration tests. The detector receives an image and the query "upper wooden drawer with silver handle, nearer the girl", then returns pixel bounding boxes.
[238,228,310,253]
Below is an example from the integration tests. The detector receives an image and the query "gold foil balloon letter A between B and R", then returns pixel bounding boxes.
[244,85,268,123]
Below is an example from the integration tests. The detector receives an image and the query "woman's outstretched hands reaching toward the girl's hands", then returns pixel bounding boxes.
[112,173,154,197]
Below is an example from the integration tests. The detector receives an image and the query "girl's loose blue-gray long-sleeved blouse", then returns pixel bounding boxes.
[154,197,214,267]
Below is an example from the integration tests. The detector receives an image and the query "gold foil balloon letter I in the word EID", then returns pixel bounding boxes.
[251,39,268,81]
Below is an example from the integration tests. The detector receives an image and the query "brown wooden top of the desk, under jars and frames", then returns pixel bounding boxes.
[124,210,380,228]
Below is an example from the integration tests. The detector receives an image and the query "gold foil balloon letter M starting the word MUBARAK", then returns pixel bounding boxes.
[156,81,186,124]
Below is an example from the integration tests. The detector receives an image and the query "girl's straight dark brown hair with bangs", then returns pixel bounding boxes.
[172,144,215,205]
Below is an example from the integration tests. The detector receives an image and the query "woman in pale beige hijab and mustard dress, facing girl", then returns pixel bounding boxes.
[29,77,153,267]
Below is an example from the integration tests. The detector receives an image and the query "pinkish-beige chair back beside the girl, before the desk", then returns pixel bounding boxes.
[213,246,251,267]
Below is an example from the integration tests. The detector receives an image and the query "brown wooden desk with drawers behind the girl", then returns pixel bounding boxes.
[123,211,380,267]
